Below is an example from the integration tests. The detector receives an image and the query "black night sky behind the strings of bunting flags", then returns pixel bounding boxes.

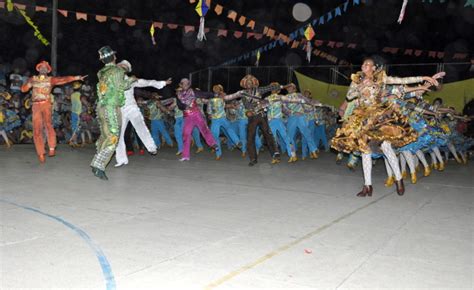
[0,0,474,84]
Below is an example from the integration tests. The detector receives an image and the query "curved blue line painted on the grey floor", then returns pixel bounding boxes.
[0,199,116,290]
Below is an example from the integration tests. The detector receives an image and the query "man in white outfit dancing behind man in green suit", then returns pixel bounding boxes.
[115,60,171,167]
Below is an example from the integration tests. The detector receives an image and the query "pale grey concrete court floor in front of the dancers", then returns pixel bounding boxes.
[0,145,474,289]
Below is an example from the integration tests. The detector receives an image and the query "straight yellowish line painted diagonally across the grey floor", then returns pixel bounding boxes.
[204,192,393,290]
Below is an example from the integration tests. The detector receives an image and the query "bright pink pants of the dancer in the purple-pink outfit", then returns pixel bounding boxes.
[183,112,216,158]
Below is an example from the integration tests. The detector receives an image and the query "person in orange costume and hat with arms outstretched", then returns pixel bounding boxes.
[21,61,81,162]
